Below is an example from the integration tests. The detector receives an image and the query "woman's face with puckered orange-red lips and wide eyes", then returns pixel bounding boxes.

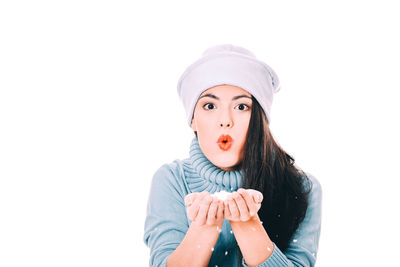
[192,84,252,171]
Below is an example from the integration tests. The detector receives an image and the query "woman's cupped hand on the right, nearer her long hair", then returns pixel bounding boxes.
[224,188,263,222]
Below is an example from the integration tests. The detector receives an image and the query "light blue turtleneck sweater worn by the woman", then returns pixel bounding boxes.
[143,138,322,267]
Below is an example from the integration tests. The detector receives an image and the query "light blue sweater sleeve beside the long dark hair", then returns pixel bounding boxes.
[242,174,322,267]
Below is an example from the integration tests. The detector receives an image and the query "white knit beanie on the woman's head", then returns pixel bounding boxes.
[178,44,280,126]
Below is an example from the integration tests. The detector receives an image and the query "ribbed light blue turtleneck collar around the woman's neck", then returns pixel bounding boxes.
[183,137,242,194]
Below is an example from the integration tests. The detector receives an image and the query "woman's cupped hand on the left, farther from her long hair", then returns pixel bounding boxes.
[185,191,224,229]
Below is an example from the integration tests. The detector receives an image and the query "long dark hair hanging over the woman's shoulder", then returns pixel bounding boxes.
[239,96,312,266]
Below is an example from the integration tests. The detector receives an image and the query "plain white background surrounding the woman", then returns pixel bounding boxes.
[0,0,400,266]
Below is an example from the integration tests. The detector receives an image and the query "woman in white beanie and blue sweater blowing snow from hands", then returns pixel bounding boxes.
[144,44,322,266]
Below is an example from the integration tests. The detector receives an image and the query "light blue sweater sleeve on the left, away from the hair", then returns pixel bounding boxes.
[143,164,189,267]
